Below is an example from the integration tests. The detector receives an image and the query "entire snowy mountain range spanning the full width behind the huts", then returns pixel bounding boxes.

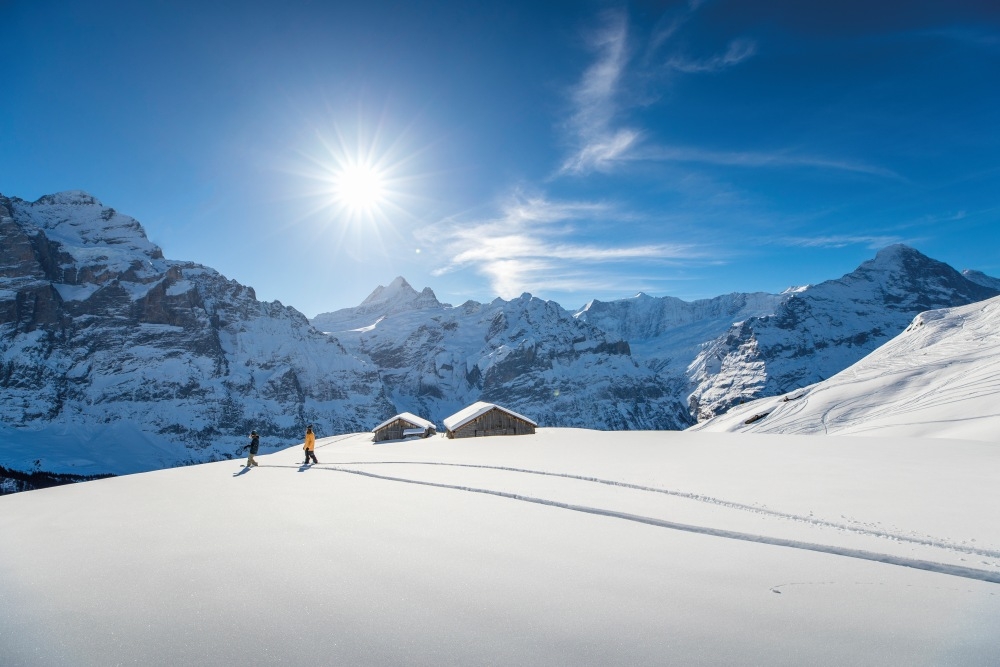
[0,191,1000,490]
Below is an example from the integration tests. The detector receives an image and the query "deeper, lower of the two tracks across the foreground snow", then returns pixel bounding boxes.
[314,466,1000,584]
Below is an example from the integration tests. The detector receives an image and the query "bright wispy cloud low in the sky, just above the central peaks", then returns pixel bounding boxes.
[423,192,702,298]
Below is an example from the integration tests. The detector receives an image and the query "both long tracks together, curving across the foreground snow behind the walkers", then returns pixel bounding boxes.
[254,461,1000,584]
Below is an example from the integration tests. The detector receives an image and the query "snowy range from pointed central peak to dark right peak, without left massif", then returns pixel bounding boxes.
[313,245,998,429]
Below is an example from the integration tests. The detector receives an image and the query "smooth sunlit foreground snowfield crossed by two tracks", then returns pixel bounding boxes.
[0,429,1000,665]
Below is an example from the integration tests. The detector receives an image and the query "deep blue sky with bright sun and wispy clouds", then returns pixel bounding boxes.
[0,0,1000,317]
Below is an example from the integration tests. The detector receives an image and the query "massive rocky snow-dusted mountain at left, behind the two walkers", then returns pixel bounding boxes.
[0,192,393,482]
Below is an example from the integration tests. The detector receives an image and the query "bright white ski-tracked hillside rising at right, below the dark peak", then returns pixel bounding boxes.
[691,297,1000,442]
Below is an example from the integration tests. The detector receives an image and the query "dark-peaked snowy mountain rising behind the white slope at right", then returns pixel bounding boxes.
[687,245,998,420]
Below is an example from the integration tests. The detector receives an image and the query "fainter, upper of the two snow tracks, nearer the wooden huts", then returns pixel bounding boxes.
[318,461,1000,558]
